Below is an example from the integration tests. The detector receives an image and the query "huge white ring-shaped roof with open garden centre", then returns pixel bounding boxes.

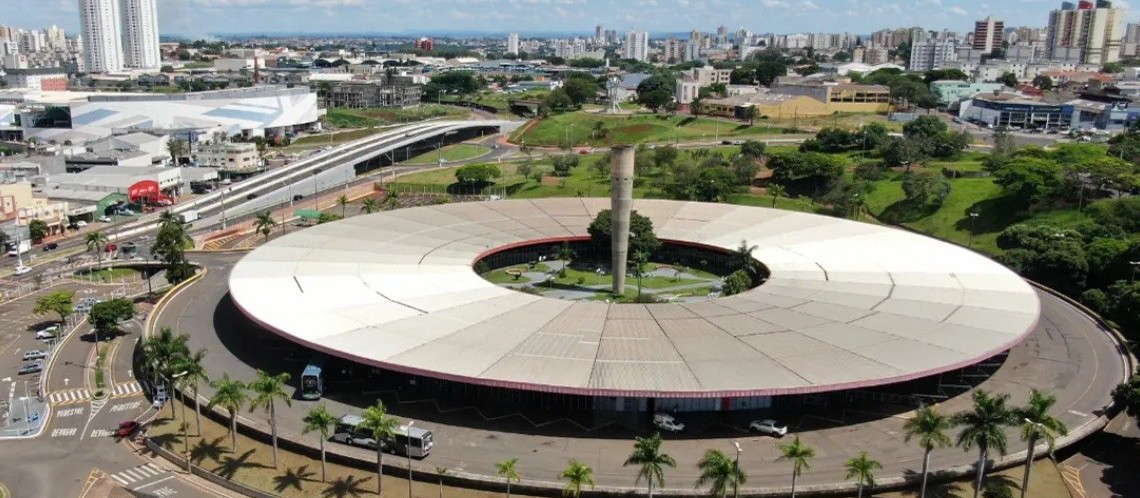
[229,198,1040,398]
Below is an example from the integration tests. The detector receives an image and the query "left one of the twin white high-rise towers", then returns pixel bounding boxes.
[79,0,123,73]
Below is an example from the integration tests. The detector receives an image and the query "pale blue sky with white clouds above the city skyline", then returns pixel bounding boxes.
[0,0,1138,38]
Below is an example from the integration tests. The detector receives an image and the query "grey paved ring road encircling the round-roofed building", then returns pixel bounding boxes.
[157,250,1123,485]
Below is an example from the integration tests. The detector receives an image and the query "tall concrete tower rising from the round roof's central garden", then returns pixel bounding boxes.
[610,146,634,294]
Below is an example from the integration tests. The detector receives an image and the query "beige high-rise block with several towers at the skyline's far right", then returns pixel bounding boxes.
[1045,0,1126,64]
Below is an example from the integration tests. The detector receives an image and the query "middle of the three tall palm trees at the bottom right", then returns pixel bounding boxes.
[951,390,1017,498]
